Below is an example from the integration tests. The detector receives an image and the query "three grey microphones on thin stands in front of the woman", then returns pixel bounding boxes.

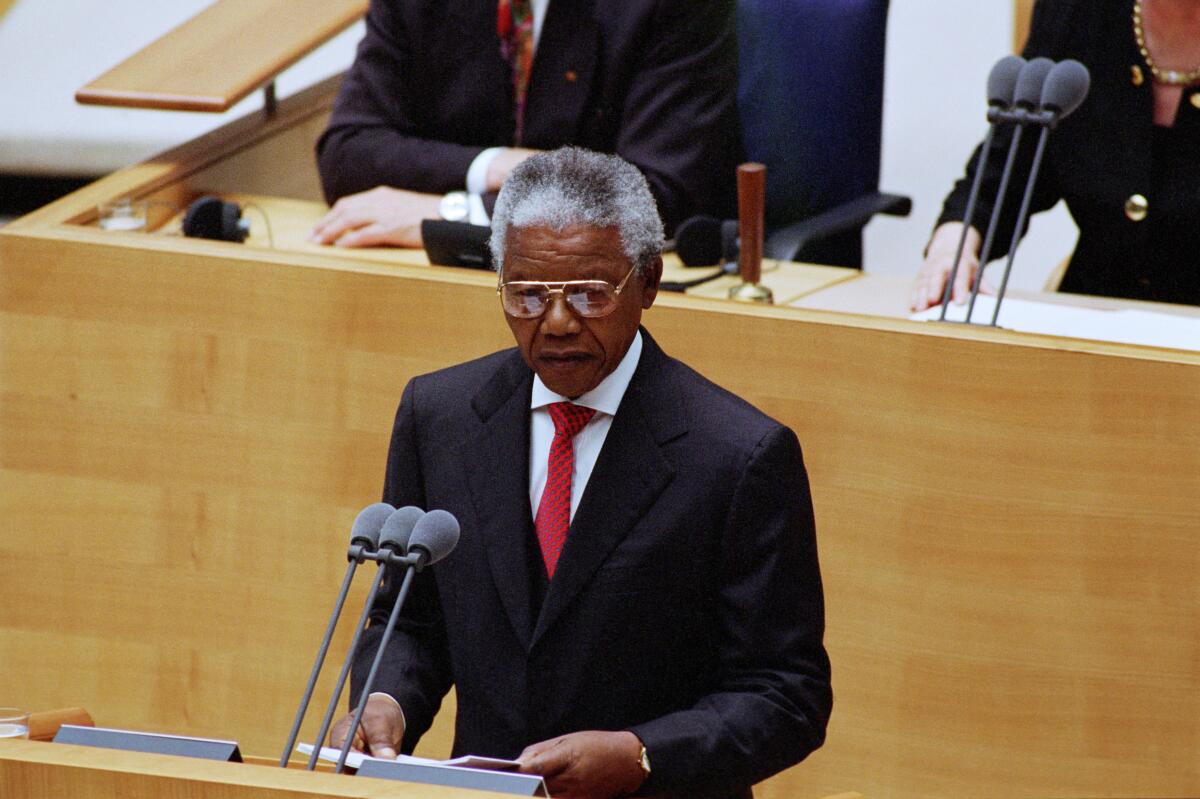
[938,55,1091,328]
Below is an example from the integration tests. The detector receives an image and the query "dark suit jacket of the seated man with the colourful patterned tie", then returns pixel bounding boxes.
[317,0,742,228]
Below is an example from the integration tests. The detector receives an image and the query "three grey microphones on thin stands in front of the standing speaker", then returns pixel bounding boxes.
[280,503,460,773]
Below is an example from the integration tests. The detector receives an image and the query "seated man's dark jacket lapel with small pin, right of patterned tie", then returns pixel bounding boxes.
[523,0,600,148]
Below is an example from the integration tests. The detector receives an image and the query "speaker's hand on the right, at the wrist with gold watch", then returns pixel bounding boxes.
[517,731,646,799]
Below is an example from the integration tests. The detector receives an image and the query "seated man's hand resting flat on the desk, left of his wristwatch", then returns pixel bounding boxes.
[308,186,442,247]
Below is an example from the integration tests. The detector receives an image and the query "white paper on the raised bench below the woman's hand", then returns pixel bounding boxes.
[908,294,1200,352]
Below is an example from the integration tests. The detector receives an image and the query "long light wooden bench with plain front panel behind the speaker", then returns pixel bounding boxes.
[0,76,1200,799]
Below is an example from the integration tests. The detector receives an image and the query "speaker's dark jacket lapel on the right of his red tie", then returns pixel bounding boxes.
[532,330,686,645]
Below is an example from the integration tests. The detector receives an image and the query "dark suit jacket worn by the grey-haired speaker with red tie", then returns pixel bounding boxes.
[352,331,832,797]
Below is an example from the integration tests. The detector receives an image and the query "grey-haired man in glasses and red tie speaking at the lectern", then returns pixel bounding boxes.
[332,148,832,797]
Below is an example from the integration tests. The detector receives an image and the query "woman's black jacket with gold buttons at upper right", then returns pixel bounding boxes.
[938,0,1200,304]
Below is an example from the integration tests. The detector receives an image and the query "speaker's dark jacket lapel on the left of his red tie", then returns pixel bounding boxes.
[462,350,533,651]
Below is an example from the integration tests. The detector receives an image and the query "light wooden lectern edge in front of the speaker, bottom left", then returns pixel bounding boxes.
[0,740,506,799]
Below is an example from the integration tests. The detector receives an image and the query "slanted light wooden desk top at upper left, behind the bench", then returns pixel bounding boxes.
[76,0,367,113]
